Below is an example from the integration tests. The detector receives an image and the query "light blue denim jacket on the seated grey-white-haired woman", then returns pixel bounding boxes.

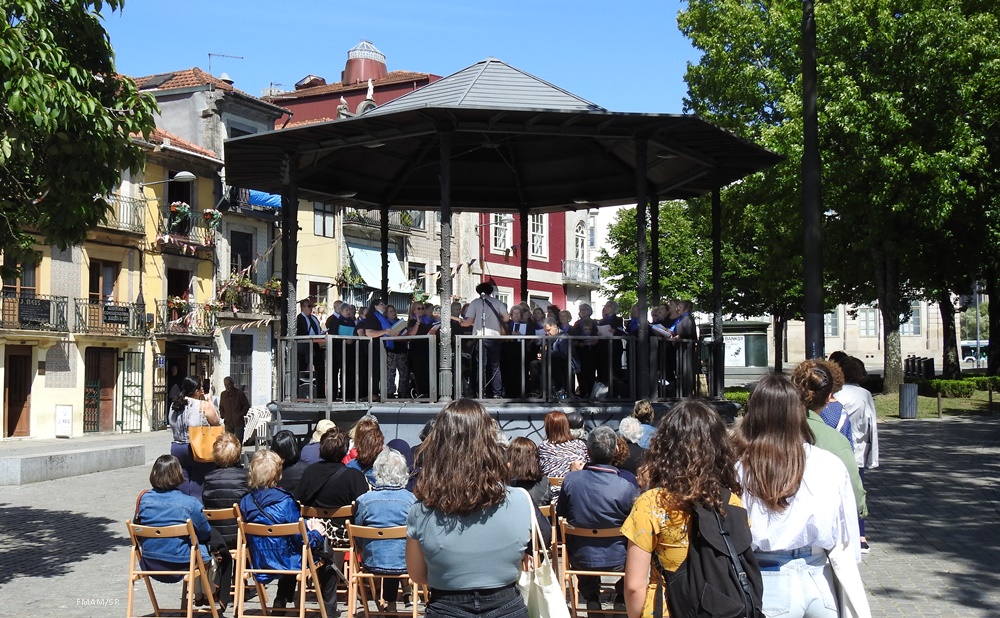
[354,485,417,574]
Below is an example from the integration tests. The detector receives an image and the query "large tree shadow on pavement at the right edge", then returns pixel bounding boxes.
[865,415,1000,612]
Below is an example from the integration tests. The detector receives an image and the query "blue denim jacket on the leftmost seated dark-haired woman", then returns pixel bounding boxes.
[135,489,212,564]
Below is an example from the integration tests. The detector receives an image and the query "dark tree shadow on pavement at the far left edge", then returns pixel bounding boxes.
[0,504,129,584]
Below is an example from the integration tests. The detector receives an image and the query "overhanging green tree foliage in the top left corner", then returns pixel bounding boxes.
[0,0,156,276]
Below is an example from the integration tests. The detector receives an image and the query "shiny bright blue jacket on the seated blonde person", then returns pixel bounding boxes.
[240,487,323,583]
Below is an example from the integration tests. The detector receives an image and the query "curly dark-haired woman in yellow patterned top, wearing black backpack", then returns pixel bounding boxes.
[622,400,749,618]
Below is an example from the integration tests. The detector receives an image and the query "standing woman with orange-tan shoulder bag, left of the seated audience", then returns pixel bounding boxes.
[169,376,222,500]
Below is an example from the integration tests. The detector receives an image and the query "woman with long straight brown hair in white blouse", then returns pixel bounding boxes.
[734,374,871,618]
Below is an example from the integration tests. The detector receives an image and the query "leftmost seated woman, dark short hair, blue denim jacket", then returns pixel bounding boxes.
[133,455,225,605]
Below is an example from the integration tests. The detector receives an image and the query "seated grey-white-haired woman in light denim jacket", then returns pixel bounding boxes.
[354,448,417,612]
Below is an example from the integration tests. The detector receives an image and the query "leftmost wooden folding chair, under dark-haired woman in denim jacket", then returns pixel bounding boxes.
[125,519,219,618]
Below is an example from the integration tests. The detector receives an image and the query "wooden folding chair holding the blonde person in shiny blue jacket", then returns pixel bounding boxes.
[236,517,327,618]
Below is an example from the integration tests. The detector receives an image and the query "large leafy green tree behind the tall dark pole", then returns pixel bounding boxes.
[678,0,1000,392]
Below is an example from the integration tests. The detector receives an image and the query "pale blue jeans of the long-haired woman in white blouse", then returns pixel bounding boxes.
[757,551,837,618]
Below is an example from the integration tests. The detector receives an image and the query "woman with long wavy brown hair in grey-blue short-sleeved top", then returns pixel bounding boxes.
[406,399,534,617]
